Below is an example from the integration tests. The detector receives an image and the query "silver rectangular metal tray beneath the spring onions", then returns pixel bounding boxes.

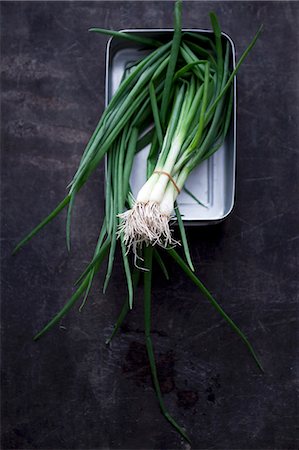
[105,29,236,225]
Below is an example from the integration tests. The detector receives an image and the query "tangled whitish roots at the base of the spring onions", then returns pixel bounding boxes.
[118,201,179,257]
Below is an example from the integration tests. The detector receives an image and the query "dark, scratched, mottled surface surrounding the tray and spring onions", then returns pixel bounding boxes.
[1,1,299,449]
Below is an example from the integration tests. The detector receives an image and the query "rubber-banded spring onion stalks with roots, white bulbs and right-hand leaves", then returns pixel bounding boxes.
[119,13,259,254]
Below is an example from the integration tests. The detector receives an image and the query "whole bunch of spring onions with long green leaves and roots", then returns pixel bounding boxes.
[15,1,262,440]
